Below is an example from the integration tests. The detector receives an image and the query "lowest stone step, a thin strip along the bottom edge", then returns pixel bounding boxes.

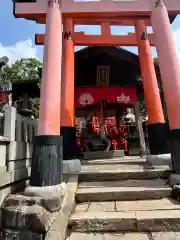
[66,232,180,240]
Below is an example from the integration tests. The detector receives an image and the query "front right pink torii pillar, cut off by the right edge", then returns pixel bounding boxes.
[151,0,180,174]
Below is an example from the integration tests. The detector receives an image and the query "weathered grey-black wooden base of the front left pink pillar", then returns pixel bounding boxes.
[30,135,63,186]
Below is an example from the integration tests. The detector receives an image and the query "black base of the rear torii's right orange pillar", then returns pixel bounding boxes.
[147,123,170,155]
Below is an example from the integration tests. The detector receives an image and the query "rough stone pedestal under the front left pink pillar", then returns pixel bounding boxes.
[1,183,66,240]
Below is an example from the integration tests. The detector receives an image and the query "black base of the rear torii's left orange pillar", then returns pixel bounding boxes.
[61,126,79,160]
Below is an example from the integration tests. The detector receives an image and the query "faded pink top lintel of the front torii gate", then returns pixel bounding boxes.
[14,0,180,19]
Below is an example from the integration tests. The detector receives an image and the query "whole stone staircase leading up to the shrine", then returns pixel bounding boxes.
[67,157,180,240]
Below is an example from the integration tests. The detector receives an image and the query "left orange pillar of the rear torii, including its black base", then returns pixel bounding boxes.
[61,18,77,160]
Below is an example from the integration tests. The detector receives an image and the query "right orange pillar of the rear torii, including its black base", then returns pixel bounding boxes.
[135,20,169,155]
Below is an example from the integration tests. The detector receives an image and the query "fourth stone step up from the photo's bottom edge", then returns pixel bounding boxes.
[79,164,171,182]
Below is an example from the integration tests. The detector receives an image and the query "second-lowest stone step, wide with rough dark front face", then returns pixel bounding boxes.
[69,210,180,232]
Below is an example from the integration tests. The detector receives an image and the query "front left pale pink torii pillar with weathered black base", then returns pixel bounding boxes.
[30,1,62,187]
